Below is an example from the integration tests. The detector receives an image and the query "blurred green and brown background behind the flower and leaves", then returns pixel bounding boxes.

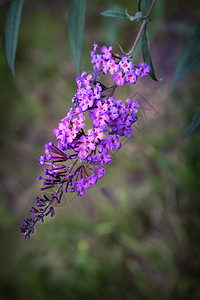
[0,0,200,300]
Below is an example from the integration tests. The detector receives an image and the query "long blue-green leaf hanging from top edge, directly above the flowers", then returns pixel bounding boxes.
[68,0,86,74]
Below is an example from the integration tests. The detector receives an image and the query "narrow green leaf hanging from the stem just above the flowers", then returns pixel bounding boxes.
[142,26,158,81]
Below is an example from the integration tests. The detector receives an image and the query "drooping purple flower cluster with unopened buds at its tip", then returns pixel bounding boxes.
[20,43,150,239]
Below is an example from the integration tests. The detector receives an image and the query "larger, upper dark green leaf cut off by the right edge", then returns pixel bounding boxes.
[172,25,200,89]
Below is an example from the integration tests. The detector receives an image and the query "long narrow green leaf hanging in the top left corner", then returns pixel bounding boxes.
[5,0,24,76]
